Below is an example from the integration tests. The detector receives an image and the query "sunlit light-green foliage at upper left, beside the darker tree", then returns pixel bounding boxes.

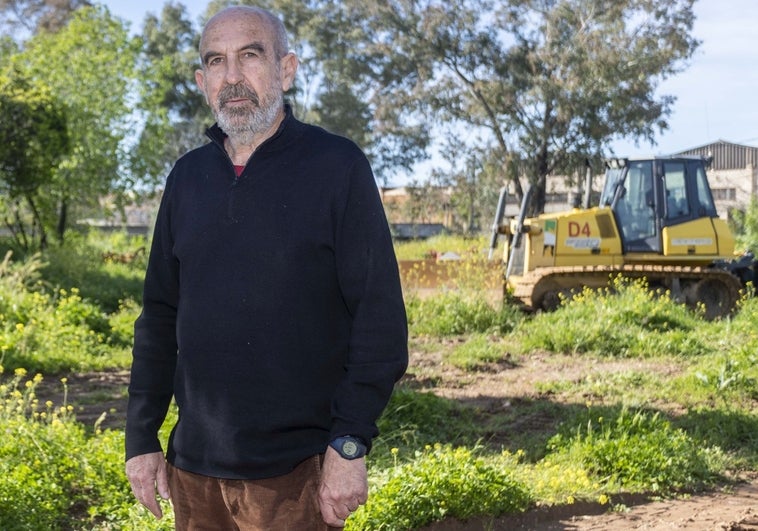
[0,7,138,247]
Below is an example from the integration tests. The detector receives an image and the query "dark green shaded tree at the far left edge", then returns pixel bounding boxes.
[0,76,70,250]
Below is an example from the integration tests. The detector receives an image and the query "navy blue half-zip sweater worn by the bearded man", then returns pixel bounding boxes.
[126,108,408,479]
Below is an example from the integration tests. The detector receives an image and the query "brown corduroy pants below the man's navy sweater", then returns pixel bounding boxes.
[168,456,338,531]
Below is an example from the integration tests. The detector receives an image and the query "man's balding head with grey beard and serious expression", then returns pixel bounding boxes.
[195,13,294,139]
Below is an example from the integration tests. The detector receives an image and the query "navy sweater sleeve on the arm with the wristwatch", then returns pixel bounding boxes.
[331,156,408,448]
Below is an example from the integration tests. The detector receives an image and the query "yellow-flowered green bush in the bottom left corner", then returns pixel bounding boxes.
[0,369,123,530]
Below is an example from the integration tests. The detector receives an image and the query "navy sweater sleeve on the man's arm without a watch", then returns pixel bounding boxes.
[126,175,179,459]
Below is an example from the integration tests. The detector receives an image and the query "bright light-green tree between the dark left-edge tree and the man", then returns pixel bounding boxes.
[7,7,139,242]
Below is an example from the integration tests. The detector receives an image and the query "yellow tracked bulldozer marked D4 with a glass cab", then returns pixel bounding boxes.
[490,156,756,319]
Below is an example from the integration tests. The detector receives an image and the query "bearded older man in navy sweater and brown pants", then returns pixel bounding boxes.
[126,7,408,531]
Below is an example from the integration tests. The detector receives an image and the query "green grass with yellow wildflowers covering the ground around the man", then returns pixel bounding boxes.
[0,236,758,531]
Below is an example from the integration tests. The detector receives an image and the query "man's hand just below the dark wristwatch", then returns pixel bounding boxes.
[318,446,368,527]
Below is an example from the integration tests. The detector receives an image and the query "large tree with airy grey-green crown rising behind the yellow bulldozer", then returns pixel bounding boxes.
[361,0,699,214]
